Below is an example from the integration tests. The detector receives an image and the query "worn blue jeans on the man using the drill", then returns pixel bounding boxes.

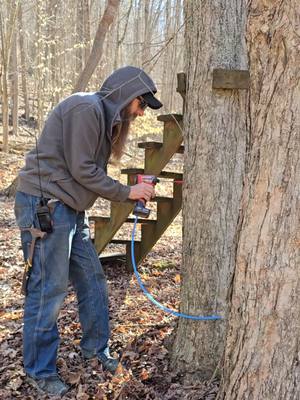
[15,192,109,378]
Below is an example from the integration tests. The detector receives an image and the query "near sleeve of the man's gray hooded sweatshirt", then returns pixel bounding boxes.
[62,104,130,201]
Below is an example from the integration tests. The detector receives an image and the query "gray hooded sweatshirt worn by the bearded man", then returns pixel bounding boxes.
[18,66,156,211]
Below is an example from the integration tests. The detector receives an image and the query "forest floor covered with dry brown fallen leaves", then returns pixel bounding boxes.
[0,123,218,400]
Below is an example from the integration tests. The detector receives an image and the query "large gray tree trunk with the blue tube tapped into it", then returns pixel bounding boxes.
[172,0,248,378]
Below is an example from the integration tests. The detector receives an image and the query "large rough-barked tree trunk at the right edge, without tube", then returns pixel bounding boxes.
[220,0,300,400]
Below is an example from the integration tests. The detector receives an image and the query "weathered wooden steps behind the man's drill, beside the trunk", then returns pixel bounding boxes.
[89,73,185,270]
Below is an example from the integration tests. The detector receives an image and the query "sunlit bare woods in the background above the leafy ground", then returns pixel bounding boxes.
[0,0,184,147]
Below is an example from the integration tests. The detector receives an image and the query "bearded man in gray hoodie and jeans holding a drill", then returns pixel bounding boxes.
[15,67,162,395]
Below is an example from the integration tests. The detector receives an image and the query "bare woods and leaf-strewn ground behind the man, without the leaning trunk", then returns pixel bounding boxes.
[0,0,204,400]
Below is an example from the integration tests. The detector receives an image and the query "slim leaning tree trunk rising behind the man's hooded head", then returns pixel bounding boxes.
[73,0,120,93]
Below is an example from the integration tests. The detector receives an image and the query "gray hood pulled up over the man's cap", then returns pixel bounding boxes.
[98,66,161,134]
